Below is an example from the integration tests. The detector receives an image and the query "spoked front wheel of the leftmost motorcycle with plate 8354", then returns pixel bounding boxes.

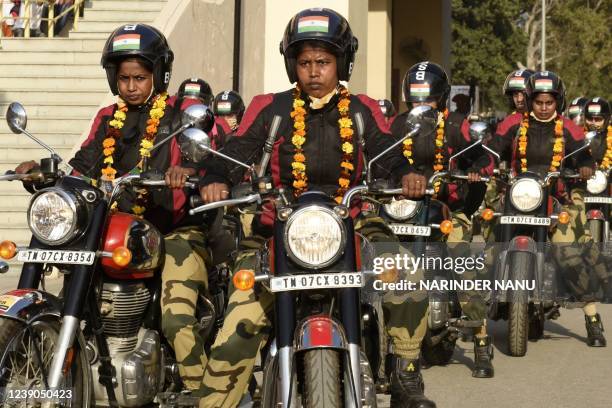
[0,316,94,408]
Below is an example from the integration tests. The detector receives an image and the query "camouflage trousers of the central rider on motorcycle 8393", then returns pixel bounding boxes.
[200,217,428,408]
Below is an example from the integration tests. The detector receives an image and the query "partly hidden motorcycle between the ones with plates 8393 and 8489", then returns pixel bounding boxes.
[379,122,496,365]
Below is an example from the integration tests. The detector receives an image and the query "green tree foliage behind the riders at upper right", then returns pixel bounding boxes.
[451,0,612,109]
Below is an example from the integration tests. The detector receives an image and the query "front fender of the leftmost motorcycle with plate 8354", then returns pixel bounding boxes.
[0,289,62,324]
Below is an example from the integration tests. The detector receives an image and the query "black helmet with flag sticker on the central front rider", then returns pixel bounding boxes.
[280,8,358,82]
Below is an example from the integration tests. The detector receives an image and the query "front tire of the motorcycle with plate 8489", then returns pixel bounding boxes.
[508,252,532,357]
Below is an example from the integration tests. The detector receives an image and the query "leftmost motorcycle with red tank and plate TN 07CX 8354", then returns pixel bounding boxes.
[0,99,229,407]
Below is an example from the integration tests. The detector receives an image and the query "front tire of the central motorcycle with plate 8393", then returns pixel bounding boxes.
[303,349,344,408]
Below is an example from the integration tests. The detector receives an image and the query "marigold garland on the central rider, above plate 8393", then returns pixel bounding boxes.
[291,85,355,203]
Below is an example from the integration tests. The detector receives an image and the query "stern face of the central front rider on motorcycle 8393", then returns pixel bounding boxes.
[296,46,338,98]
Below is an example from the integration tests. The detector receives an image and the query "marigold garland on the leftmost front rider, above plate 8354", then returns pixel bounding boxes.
[101,92,168,215]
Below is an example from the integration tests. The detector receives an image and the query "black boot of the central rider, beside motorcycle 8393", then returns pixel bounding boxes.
[390,356,436,408]
